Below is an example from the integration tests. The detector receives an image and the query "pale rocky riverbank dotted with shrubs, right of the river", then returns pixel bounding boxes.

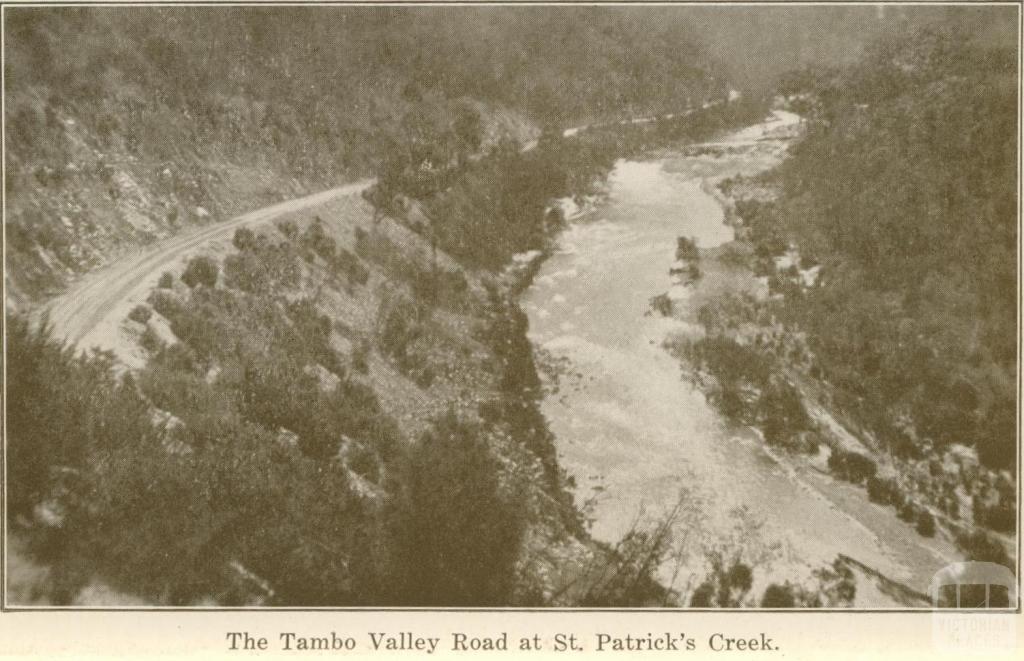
[672,154,1014,590]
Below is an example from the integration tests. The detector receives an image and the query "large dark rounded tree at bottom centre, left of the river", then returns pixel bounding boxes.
[385,410,524,606]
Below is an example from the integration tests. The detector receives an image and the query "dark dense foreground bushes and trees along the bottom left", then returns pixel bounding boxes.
[7,316,524,606]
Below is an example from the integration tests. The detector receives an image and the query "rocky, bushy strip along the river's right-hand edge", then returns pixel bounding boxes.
[655,117,991,605]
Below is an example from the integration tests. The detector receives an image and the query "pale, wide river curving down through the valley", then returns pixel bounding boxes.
[522,112,954,607]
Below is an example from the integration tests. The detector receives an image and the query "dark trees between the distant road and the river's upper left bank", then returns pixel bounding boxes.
[411,98,767,269]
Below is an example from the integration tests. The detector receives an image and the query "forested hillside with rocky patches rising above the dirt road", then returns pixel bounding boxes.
[4,7,726,301]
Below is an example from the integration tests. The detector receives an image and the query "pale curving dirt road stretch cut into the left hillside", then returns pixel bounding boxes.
[43,179,374,349]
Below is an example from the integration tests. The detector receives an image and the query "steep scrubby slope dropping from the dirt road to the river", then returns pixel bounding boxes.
[9,189,592,604]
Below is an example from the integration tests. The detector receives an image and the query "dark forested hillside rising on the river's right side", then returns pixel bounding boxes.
[680,23,1019,564]
